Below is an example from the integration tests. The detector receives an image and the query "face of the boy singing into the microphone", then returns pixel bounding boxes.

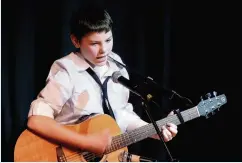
[80,31,113,66]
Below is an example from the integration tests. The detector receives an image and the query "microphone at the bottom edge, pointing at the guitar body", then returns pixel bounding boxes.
[118,151,157,162]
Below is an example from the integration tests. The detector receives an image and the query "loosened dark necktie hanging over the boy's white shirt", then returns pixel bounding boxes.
[86,67,115,119]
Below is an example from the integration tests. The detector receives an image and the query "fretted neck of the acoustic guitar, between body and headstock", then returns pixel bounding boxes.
[106,106,200,154]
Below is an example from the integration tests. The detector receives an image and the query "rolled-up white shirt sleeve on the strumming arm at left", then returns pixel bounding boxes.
[28,62,73,118]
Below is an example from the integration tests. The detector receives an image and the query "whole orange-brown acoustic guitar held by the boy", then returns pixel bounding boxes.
[14,94,227,162]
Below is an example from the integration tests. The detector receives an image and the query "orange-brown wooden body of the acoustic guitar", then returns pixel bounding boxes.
[14,115,128,162]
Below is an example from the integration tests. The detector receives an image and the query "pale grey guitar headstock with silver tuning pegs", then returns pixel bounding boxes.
[197,91,227,118]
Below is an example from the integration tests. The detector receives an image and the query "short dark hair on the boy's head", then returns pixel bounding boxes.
[70,5,113,40]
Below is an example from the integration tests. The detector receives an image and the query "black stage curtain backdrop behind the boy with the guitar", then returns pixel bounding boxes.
[1,0,242,161]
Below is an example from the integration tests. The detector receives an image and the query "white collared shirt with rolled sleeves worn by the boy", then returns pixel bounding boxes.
[28,52,147,132]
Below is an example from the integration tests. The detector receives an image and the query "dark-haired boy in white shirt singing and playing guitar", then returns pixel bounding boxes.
[28,4,177,154]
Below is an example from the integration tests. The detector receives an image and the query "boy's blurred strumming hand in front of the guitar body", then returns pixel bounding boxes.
[86,129,112,155]
